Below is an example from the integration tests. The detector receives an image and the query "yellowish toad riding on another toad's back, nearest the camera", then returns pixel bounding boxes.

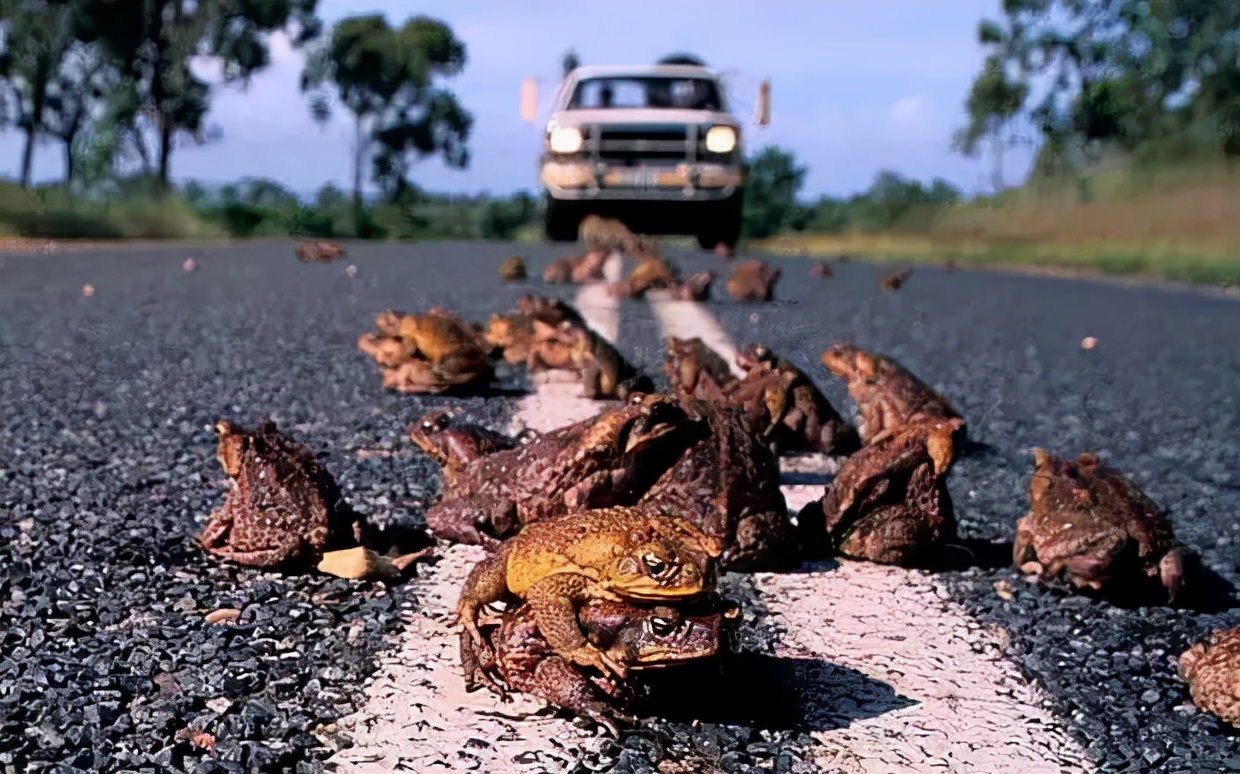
[456,507,723,677]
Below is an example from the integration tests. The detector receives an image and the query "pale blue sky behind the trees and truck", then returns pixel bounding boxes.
[0,0,1030,197]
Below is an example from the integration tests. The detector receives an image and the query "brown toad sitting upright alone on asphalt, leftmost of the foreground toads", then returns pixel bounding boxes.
[197,419,361,568]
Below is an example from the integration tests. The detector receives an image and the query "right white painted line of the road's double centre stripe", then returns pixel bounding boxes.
[651,292,1094,774]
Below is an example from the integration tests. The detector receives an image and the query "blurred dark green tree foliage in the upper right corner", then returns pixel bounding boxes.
[956,0,1240,177]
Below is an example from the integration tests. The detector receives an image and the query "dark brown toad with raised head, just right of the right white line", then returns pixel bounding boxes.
[799,419,960,566]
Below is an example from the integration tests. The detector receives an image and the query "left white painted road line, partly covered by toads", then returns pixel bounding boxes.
[330,262,622,774]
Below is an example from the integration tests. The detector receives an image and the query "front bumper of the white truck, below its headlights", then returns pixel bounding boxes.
[538,158,745,202]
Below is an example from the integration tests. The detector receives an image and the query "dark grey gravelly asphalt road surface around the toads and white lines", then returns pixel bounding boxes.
[0,239,1240,772]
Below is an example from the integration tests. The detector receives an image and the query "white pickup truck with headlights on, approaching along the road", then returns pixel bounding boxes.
[522,65,770,249]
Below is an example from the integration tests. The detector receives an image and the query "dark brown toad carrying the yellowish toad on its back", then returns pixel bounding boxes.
[460,597,740,736]
